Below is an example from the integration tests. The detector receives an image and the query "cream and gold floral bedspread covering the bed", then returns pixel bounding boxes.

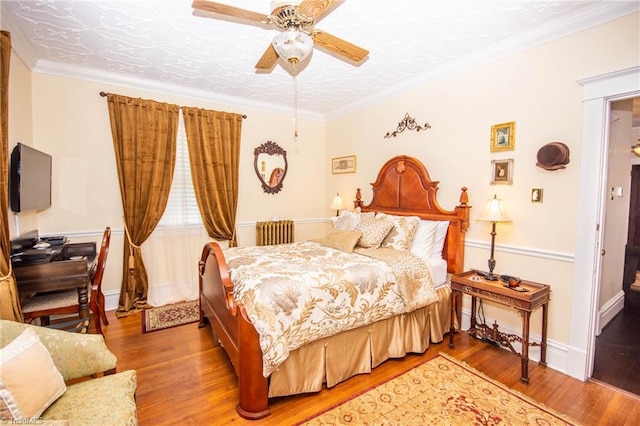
[224,241,438,377]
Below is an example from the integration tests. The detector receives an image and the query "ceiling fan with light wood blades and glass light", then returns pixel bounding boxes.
[192,0,369,72]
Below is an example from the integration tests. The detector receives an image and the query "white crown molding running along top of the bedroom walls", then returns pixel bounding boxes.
[0,1,640,121]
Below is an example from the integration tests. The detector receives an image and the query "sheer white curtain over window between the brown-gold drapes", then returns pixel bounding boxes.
[142,113,211,306]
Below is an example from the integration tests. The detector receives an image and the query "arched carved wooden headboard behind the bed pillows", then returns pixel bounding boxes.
[354,155,471,274]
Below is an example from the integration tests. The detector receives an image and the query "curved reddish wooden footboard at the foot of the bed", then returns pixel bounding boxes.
[199,242,271,420]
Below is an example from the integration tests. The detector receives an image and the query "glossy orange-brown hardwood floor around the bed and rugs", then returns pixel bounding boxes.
[96,312,640,426]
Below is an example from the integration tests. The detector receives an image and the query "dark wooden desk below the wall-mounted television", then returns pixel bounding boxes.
[13,243,96,318]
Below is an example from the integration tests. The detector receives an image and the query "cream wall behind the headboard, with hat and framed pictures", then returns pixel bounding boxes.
[327,14,640,342]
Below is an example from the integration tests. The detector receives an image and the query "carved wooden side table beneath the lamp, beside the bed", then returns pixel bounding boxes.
[449,271,551,383]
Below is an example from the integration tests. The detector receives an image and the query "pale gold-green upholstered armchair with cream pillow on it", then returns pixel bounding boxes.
[0,320,137,426]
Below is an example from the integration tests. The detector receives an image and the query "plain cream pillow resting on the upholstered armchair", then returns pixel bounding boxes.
[0,328,67,420]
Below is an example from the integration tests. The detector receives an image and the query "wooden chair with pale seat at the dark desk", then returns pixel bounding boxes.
[22,227,111,334]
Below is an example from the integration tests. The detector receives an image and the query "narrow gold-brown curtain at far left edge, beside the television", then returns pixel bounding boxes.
[0,31,22,322]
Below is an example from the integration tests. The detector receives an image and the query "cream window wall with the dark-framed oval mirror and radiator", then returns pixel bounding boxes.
[10,67,331,300]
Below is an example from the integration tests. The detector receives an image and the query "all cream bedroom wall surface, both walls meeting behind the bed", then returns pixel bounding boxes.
[10,14,640,352]
